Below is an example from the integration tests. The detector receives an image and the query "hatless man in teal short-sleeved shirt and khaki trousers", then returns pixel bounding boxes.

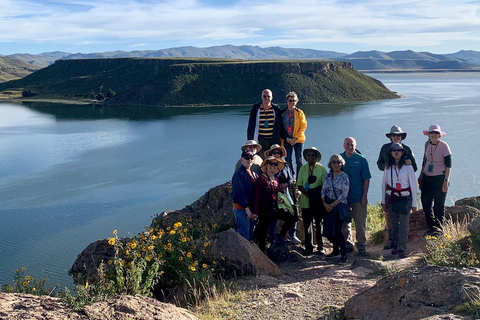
[341,137,372,256]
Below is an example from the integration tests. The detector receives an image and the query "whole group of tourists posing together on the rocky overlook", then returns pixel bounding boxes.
[232,89,451,264]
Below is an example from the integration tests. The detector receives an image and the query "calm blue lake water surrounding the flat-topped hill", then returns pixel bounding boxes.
[0,73,480,286]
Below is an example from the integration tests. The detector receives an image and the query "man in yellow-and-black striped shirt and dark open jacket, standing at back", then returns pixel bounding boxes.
[247,89,284,156]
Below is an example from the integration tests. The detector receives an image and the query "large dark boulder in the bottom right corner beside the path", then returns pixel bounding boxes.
[345,266,480,320]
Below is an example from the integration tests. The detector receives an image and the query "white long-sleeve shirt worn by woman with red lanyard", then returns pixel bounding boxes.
[382,164,417,206]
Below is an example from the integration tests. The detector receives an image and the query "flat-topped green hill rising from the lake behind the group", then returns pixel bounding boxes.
[0,58,398,105]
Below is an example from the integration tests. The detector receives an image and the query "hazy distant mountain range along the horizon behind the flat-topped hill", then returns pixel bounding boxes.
[0,45,480,81]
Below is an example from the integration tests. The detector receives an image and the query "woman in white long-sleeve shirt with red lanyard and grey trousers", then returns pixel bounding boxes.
[382,143,417,258]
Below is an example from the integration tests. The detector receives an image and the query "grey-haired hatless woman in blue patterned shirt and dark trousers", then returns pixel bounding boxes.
[322,154,350,264]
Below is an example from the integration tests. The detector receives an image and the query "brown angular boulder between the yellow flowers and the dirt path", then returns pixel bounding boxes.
[206,229,281,277]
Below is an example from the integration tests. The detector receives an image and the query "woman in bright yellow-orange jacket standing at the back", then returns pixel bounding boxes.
[282,91,307,176]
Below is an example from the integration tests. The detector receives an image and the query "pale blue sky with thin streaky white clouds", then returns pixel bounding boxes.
[0,0,480,55]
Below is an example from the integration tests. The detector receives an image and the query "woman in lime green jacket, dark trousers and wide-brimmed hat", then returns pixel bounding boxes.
[297,147,327,255]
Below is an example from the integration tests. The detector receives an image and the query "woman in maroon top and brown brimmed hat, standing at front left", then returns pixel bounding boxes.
[252,157,286,252]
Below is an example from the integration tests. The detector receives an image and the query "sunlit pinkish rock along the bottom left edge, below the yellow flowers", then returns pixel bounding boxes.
[0,292,198,320]
